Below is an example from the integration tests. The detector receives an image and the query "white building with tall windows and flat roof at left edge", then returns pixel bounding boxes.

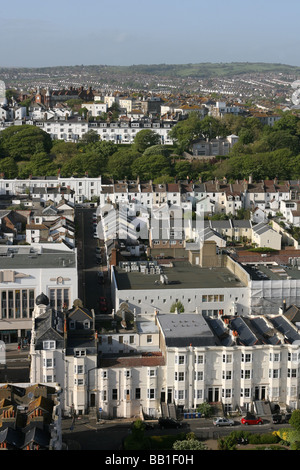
[0,243,78,343]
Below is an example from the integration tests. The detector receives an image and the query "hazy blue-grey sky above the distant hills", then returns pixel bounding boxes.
[0,0,300,67]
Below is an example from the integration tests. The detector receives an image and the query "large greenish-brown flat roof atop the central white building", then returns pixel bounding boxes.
[114,261,245,290]
